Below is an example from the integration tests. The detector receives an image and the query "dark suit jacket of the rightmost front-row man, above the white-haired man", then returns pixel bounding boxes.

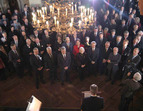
[126,54,141,66]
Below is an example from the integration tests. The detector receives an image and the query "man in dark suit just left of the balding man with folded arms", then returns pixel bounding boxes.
[99,41,112,74]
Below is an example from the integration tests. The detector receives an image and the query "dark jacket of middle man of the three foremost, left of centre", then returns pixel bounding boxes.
[44,52,57,70]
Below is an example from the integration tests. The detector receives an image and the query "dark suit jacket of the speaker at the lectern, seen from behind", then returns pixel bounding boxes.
[81,96,104,111]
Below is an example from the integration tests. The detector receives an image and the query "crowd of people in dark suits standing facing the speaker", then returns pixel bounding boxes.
[0,0,143,111]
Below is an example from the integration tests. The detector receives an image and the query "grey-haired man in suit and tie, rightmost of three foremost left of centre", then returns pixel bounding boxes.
[58,46,71,85]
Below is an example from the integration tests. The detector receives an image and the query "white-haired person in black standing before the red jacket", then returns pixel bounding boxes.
[76,47,87,81]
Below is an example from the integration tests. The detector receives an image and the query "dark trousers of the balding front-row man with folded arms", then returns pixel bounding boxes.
[107,64,119,82]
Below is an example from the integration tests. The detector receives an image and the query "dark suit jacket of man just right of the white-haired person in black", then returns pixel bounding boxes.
[87,47,99,63]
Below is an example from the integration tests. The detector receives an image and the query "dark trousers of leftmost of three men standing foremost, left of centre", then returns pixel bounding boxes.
[35,70,44,88]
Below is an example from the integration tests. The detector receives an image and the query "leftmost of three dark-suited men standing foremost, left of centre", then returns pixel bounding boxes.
[30,47,45,89]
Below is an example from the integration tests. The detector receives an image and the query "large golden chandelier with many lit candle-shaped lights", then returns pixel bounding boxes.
[32,1,94,34]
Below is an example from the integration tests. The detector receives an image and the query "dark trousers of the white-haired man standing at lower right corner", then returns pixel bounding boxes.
[119,96,133,111]
